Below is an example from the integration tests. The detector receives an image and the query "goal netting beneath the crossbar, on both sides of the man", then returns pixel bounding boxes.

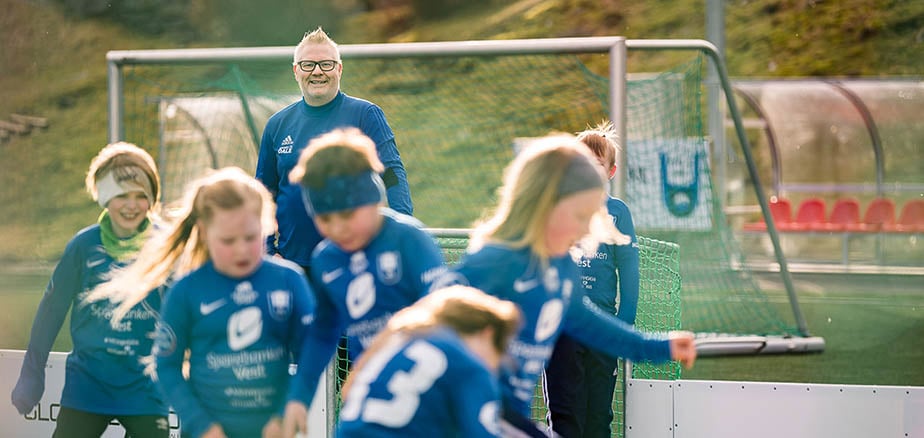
[123,55,606,217]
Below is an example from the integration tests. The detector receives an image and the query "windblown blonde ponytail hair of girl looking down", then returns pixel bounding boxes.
[86,167,275,325]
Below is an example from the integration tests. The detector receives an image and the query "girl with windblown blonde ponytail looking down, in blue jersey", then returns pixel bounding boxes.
[91,168,315,438]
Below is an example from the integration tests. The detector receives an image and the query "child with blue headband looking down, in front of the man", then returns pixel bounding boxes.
[290,128,445,436]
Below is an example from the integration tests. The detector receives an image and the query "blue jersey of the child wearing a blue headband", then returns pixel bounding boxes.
[299,208,446,408]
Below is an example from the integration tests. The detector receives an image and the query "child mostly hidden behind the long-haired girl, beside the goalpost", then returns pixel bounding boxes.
[543,122,639,438]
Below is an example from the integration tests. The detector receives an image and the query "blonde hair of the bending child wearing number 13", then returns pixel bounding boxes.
[340,285,523,396]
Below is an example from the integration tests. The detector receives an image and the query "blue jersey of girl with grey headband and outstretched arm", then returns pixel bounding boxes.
[439,245,670,417]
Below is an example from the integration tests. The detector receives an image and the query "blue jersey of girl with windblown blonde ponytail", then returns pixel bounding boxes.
[154,256,315,437]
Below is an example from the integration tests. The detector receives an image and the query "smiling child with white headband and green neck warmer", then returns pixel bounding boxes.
[12,143,170,437]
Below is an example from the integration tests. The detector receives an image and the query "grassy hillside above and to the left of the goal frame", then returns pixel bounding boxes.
[0,0,924,263]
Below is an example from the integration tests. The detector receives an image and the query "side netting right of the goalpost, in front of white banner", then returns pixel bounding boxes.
[608,59,799,336]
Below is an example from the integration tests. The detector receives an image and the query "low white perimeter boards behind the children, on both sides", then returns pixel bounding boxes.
[0,350,924,438]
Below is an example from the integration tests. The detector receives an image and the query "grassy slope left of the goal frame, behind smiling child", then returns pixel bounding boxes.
[0,0,180,262]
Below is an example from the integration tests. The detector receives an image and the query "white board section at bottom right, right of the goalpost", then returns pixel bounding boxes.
[626,380,924,438]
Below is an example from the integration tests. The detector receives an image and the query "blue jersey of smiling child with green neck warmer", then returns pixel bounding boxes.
[12,224,168,415]
